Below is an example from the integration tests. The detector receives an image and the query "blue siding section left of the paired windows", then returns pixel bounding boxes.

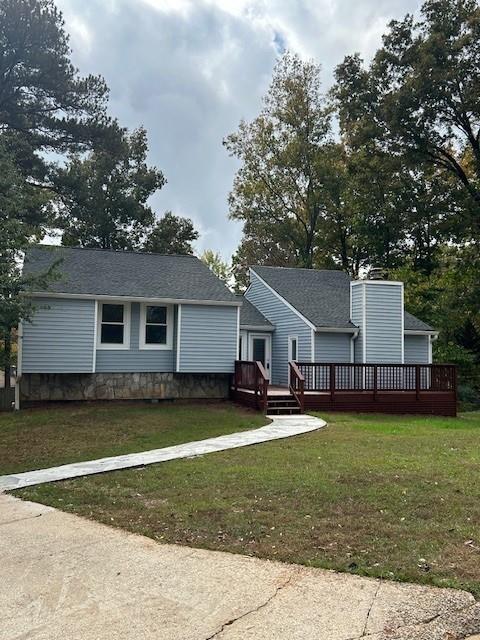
[22,298,95,373]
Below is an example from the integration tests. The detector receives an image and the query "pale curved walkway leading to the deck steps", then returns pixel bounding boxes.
[0,415,326,491]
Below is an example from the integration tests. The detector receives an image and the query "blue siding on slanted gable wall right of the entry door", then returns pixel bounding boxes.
[245,271,312,385]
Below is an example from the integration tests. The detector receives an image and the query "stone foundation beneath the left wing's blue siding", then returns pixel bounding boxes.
[20,373,231,403]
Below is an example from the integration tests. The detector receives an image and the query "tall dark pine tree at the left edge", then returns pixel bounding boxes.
[0,0,152,381]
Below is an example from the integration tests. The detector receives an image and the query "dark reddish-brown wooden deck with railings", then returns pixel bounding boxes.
[231,363,457,416]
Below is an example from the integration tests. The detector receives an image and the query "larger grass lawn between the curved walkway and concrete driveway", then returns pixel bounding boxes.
[15,413,480,596]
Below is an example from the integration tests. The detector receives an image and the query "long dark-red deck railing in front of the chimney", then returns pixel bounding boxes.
[297,362,457,398]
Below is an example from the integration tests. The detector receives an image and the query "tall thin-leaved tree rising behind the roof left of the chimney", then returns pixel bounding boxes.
[224,53,330,267]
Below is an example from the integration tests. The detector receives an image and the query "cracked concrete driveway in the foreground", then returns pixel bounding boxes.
[0,495,480,640]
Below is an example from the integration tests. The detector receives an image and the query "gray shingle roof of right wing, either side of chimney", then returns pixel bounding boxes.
[252,267,432,331]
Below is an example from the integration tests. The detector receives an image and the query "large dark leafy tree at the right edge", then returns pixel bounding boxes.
[332,0,480,396]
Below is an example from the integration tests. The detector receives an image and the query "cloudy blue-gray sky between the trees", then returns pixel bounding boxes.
[56,0,420,259]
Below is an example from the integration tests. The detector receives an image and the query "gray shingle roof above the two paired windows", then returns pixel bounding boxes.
[24,245,237,303]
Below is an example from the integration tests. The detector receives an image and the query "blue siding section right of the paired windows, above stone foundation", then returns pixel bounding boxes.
[178,304,238,373]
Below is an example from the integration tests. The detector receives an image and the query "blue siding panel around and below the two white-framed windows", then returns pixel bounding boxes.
[95,302,176,373]
